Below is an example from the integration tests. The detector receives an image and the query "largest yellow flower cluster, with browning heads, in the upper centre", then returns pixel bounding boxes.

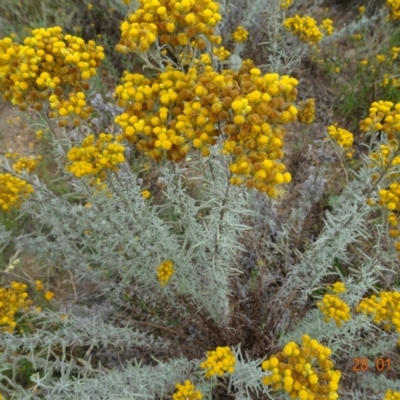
[115,60,314,197]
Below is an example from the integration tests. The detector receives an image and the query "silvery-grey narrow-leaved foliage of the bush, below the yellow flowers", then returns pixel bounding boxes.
[0,131,397,399]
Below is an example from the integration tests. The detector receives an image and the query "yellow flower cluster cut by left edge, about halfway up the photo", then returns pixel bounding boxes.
[0,173,33,211]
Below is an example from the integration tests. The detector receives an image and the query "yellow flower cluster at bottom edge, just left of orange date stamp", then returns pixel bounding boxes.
[262,335,341,400]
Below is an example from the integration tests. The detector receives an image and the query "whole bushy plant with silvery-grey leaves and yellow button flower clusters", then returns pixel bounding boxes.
[0,0,400,400]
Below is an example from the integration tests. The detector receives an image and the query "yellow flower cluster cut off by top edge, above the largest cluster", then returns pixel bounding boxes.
[116,0,222,53]
